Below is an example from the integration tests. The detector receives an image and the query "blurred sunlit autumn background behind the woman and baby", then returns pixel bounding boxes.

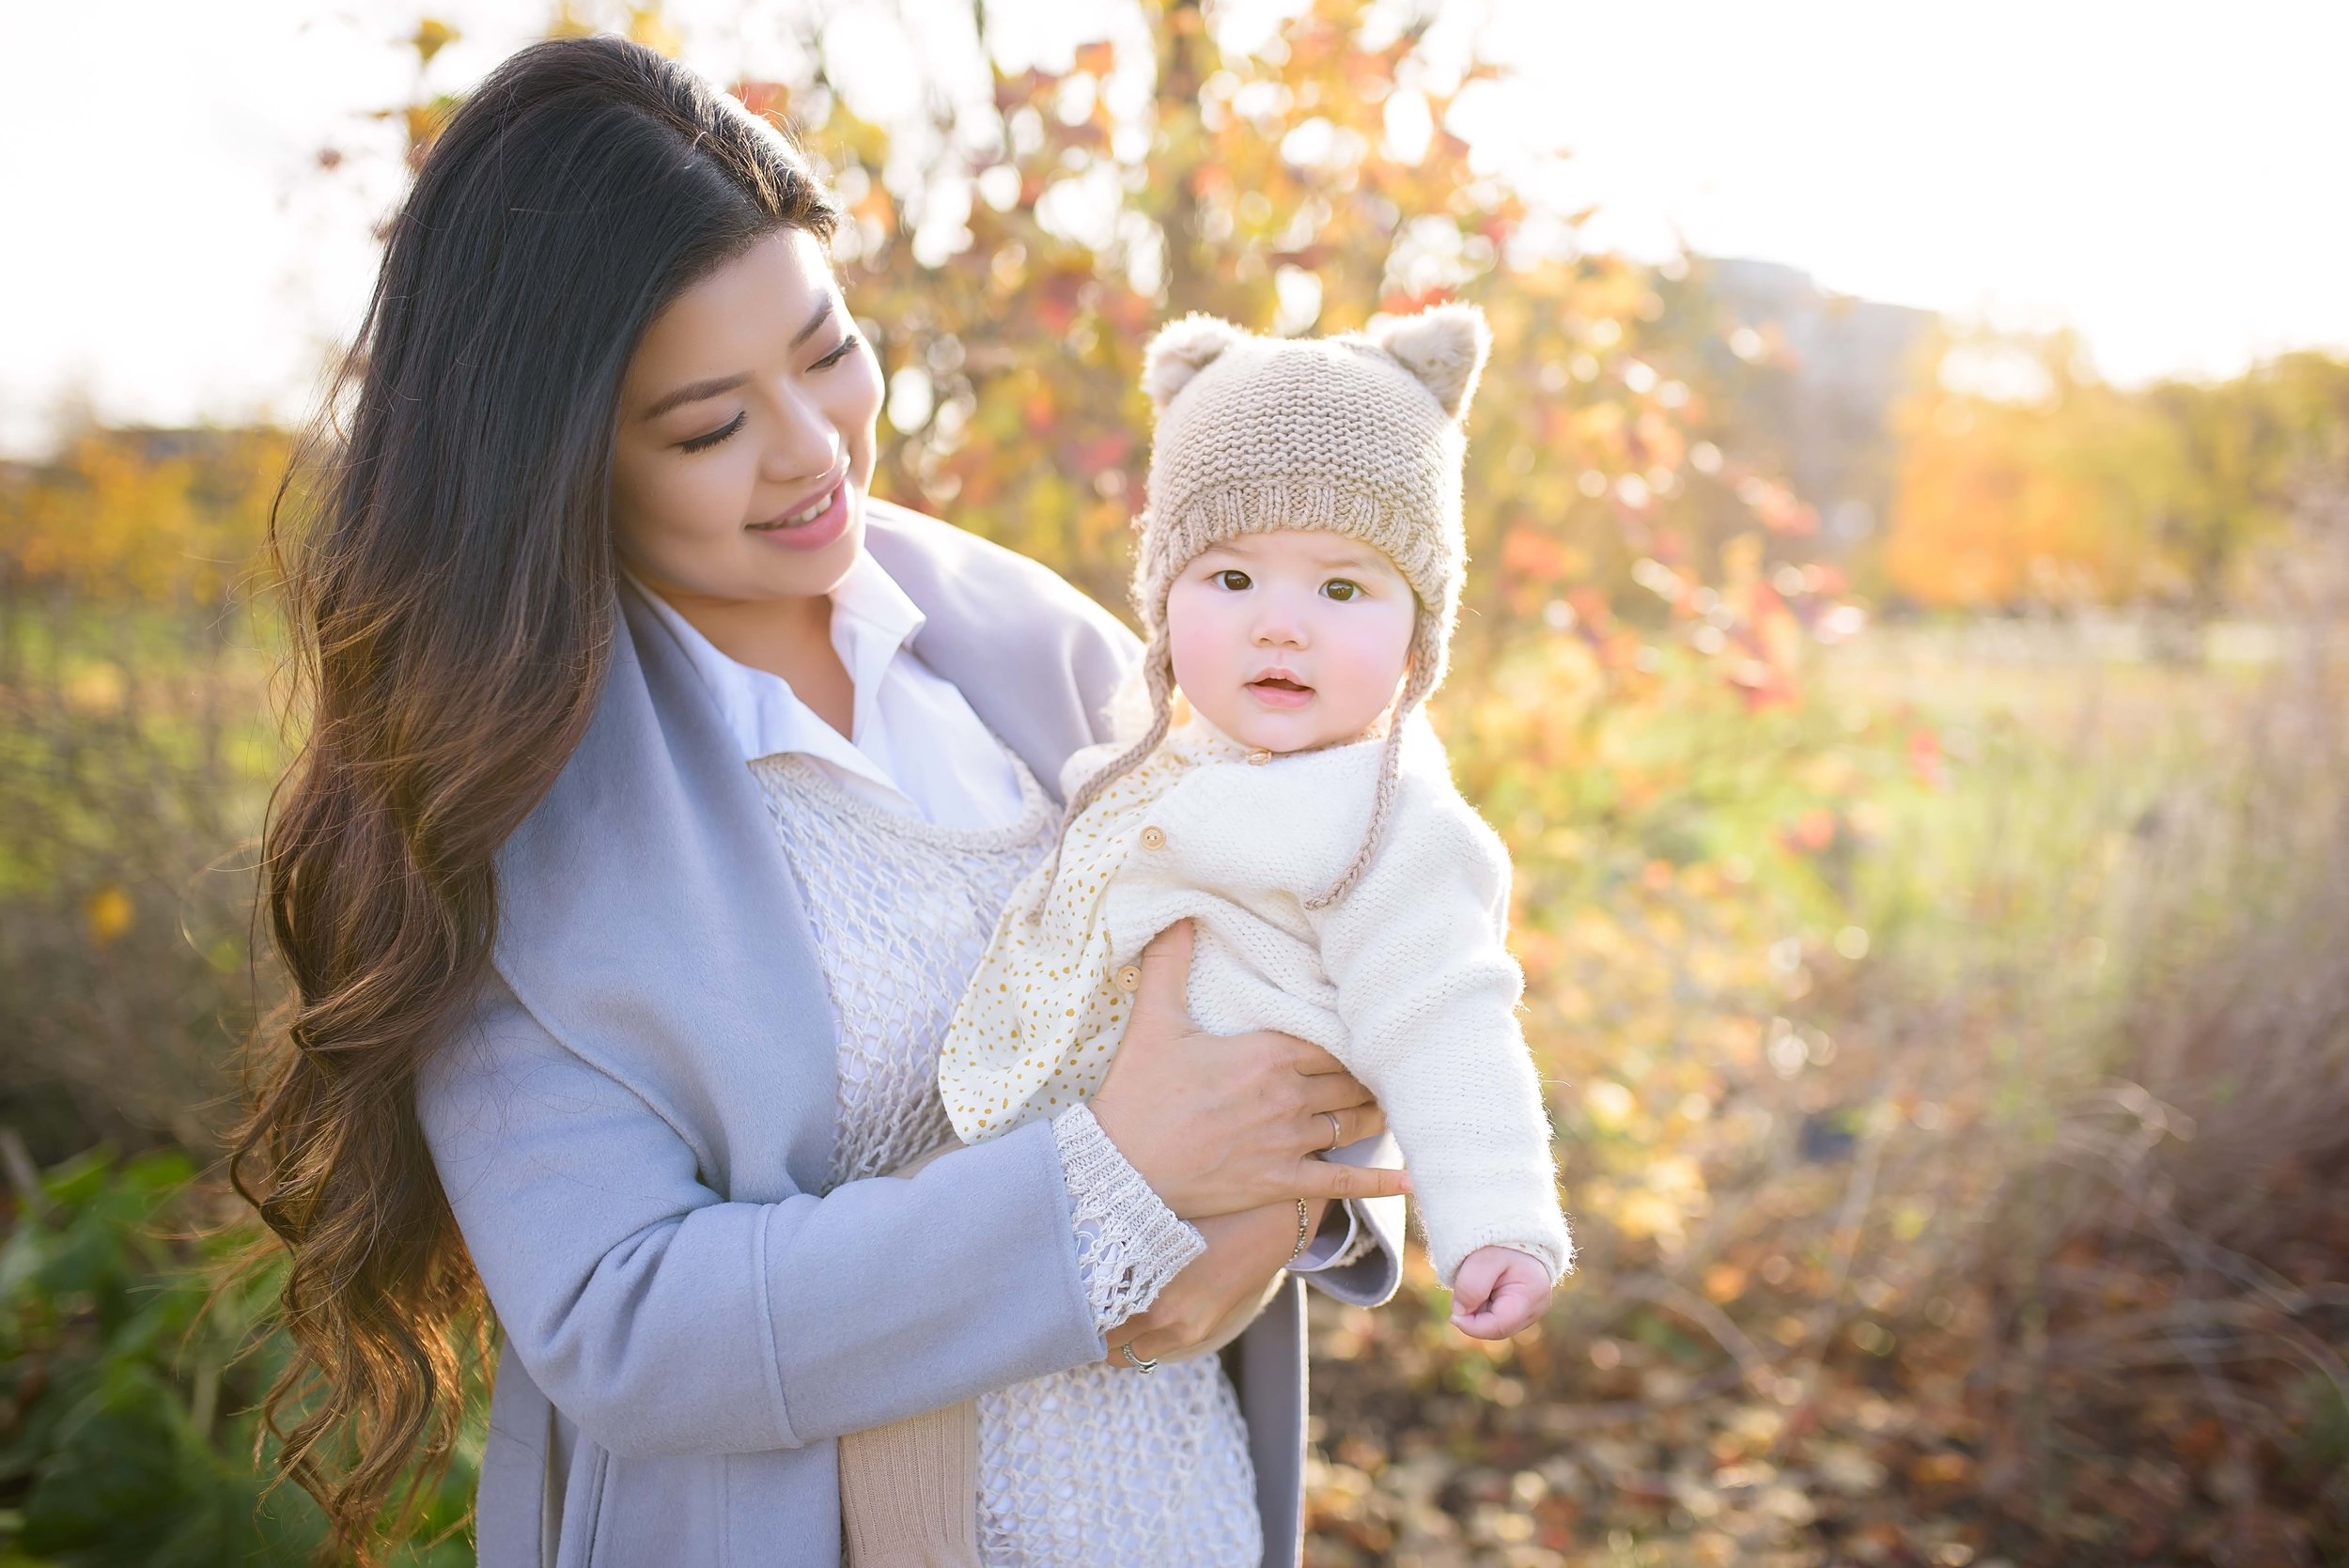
[0,0,2349,1568]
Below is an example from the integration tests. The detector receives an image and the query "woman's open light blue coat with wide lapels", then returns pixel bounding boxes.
[418,503,1403,1568]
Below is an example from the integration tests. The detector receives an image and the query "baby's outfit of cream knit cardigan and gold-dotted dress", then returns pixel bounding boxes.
[940,714,1574,1284]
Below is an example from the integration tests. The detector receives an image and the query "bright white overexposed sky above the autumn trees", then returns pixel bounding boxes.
[0,0,2349,453]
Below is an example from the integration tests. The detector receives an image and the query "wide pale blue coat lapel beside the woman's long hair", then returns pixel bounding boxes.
[498,587,836,1202]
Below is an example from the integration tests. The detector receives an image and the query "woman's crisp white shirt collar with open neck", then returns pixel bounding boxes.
[630,551,1022,829]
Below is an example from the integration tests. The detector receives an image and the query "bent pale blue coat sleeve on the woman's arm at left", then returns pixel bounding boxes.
[418,981,1107,1455]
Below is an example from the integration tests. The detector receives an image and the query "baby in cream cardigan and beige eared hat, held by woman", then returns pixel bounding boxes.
[841,305,1572,1561]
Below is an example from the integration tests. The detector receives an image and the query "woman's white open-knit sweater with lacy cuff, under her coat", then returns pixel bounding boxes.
[750,753,1262,1568]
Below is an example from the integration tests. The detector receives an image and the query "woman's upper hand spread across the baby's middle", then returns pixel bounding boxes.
[1093,920,1412,1220]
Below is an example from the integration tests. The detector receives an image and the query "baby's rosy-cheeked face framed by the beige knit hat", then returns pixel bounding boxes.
[1168,528,1419,752]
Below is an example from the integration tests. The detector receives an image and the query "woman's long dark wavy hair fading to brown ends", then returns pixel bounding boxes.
[230,38,834,1561]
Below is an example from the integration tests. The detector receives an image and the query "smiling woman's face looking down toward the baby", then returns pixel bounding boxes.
[614,227,881,608]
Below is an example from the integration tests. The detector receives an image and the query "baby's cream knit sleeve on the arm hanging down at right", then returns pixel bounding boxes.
[1320,777,1574,1284]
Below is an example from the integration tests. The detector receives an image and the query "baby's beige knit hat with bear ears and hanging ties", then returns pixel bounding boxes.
[1043,305,1492,908]
